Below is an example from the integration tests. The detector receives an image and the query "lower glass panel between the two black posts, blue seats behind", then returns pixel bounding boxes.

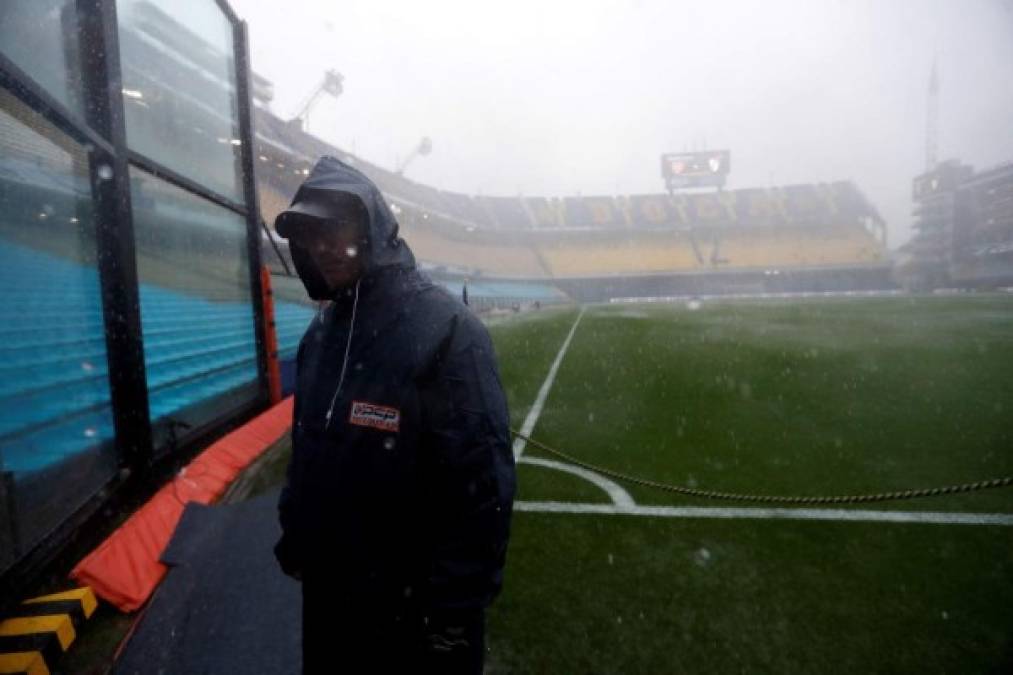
[131,166,258,454]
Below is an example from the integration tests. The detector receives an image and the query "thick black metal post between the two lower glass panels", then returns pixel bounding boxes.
[77,0,152,470]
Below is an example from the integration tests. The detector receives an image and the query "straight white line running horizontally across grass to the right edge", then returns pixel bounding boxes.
[514,502,1013,526]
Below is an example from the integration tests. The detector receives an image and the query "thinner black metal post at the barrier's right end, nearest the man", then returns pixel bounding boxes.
[233,20,274,400]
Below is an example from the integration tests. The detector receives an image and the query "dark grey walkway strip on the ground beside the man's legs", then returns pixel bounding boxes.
[113,490,302,675]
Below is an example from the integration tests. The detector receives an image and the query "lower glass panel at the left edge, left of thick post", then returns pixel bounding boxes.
[0,89,118,569]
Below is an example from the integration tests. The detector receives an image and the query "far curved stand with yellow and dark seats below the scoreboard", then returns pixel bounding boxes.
[249,109,885,279]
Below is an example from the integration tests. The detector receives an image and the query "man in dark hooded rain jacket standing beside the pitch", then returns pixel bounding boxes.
[276,157,515,675]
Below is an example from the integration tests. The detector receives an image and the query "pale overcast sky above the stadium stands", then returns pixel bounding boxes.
[232,0,1013,248]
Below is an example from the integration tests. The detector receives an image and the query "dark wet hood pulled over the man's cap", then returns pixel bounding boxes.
[275,156,415,277]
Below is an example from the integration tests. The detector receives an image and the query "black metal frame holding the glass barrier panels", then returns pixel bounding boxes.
[0,0,268,589]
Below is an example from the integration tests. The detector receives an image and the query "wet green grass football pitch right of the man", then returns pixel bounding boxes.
[487,295,1013,674]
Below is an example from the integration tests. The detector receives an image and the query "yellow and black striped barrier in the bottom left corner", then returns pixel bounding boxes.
[0,587,98,675]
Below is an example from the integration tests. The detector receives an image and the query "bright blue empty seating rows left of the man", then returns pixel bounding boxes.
[0,241,312,473]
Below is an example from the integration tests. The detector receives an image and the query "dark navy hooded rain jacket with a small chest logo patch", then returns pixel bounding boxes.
[276,157,515,612]
